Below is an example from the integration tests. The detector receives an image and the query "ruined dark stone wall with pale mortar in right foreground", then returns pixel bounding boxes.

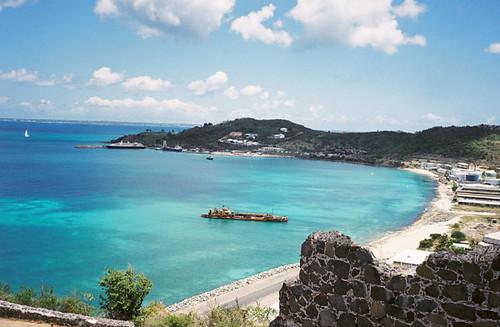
[271,232,500,327]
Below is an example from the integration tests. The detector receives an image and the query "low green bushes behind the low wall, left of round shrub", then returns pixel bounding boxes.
[0,284,95,316]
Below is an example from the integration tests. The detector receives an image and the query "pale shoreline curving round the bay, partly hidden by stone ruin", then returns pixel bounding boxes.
[167,168,462,313]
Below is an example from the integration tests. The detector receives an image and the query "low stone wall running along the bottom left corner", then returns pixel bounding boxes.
[0,301,134,327]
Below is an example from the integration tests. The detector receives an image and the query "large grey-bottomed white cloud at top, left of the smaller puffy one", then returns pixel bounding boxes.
[94,0,235,37]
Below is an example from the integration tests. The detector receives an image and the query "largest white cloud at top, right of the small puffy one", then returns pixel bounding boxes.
[290,0,426,54]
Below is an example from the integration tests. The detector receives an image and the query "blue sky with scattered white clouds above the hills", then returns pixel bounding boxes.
[0,0,500,131]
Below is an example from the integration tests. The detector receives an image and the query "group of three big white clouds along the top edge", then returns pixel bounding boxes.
[90,0,426,54]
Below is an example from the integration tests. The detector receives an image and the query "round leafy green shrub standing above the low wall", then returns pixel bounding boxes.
[99,267,153,320]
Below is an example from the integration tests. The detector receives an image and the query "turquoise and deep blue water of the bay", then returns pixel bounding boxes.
[0,122,435,303]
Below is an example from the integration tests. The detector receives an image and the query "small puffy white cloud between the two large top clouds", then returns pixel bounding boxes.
[231,4,293,46]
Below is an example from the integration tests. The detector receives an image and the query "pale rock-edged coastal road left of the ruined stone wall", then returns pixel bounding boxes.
[179,268,299,315]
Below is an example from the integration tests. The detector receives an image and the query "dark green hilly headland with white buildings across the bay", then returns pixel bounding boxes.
[111,118,500,166]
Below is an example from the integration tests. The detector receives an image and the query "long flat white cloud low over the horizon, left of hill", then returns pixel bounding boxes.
[85,96,215,114]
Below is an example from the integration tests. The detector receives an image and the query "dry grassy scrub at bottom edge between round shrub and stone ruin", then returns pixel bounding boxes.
[139,305,277,327]
